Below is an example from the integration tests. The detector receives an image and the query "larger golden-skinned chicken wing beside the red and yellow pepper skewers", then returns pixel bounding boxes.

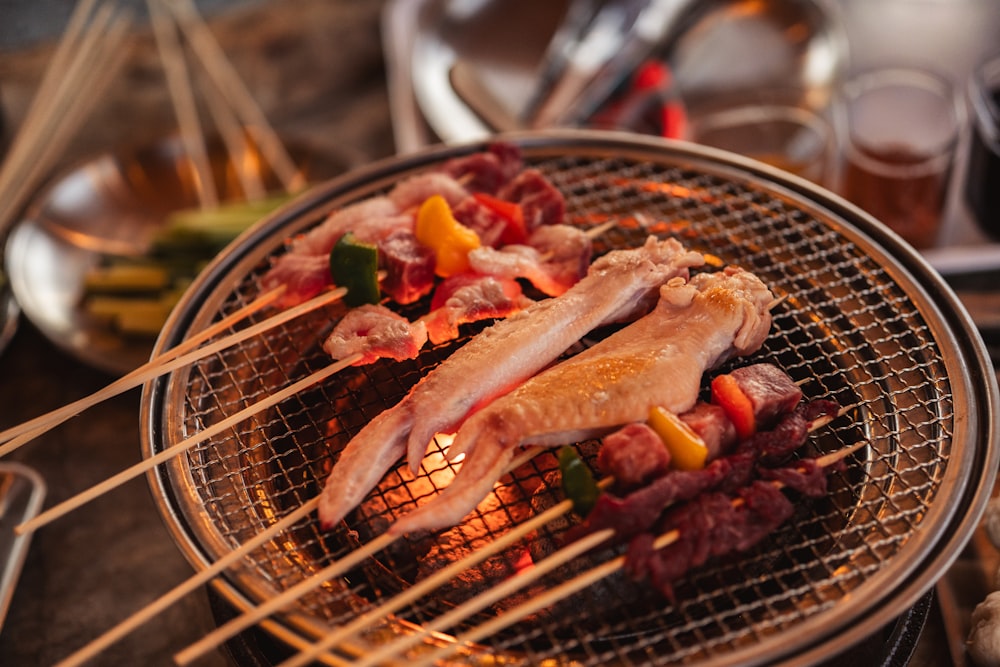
[390,268,772,533]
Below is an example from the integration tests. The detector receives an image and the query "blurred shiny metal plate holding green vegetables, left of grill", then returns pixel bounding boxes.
[4,138,344,374]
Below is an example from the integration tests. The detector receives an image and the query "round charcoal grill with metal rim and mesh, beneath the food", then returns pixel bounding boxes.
[143,131,997,665]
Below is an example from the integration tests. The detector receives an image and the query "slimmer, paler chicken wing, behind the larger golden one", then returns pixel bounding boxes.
[319,237,704,527]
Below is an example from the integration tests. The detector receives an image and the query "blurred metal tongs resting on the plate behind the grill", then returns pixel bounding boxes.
[520,0,693,127]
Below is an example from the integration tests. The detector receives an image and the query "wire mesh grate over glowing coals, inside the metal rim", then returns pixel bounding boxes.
[148,137,984,665]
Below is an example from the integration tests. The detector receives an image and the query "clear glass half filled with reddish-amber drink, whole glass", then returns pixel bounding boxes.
[840,68,959,249]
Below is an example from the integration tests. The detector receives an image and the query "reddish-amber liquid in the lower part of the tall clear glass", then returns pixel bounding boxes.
[843,146,950,248]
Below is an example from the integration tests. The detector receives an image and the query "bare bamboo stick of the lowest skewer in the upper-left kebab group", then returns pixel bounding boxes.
[14,354,361,535]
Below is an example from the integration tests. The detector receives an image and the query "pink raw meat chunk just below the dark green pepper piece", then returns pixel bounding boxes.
[323,304,427,366]
